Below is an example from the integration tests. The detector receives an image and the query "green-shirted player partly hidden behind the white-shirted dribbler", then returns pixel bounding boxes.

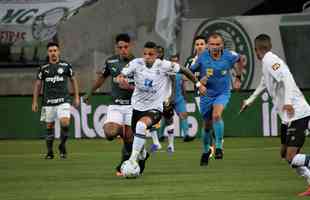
[84,33,134,176]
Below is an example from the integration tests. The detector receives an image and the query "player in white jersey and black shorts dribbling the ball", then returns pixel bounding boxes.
[117,42,206,174]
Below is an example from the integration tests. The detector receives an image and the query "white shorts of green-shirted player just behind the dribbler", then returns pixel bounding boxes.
[104,105,132,126]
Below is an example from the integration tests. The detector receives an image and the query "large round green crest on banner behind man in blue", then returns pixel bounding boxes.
[192,18,255,89]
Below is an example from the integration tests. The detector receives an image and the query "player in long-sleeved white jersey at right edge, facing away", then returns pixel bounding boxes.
[241,34,310,196]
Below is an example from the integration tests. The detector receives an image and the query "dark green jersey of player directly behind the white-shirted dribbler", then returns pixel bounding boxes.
[100,55,134,105]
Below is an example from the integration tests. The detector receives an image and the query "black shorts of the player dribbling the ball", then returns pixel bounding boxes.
[131,109,161,133]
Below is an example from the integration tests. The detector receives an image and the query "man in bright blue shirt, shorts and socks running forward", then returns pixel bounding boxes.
[191,33,241,166]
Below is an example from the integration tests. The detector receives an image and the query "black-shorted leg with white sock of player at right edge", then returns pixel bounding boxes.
[286,117,310,196]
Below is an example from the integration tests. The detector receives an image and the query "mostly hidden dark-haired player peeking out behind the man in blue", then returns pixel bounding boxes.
[181,35,207,142]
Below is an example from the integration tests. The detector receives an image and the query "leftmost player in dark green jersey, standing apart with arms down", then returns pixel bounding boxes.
[32,42,80,159]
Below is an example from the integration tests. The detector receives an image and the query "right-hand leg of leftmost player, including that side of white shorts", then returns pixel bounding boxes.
[57,103,71,158]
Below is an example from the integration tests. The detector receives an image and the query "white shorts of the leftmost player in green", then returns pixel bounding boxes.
[40,103,71,123]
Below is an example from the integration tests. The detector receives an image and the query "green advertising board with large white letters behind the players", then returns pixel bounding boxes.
[0,91,298,139]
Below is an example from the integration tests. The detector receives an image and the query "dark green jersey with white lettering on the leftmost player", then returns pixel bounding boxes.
[37,61,74,106]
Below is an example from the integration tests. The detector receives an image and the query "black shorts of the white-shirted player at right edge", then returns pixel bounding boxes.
[285,116,310,148]
